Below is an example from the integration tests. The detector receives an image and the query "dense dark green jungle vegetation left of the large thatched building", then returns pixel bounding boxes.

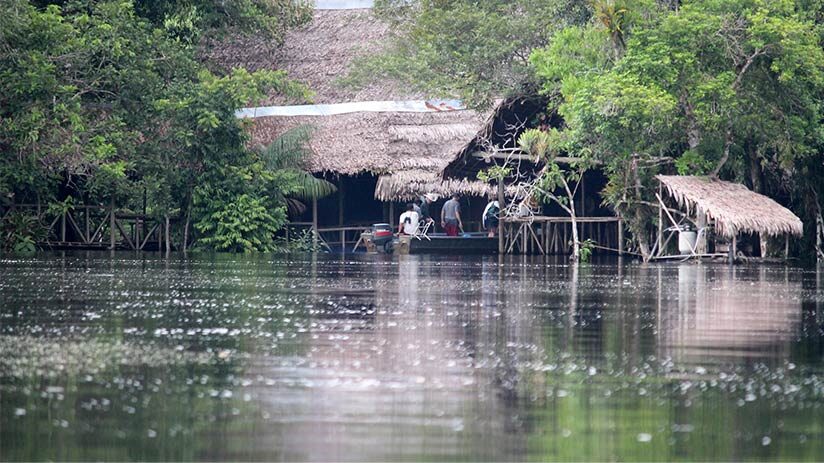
[0,0,332,251]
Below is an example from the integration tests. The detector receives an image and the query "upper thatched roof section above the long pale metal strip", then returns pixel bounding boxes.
[205,9,418,105]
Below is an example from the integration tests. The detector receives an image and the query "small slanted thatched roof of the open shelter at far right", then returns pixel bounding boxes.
[656,175,804,238]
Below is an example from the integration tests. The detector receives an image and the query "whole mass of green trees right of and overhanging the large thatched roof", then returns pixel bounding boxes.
[362,0,824,256]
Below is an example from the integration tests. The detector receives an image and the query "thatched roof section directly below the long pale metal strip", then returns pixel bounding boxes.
[250,111,484,175]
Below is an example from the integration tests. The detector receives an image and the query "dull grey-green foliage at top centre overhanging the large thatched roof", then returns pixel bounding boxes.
[348,0,590,106]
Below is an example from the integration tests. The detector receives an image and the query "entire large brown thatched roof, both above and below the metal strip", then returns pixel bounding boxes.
[212,9,496,200]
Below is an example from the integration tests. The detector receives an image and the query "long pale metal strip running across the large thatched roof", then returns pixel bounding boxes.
[235,100,466,119]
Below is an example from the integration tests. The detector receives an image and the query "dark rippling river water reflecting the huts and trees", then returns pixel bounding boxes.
[0,252,824,461]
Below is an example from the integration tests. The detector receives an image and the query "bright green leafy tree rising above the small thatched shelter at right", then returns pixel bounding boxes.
[532,0,824,256]
